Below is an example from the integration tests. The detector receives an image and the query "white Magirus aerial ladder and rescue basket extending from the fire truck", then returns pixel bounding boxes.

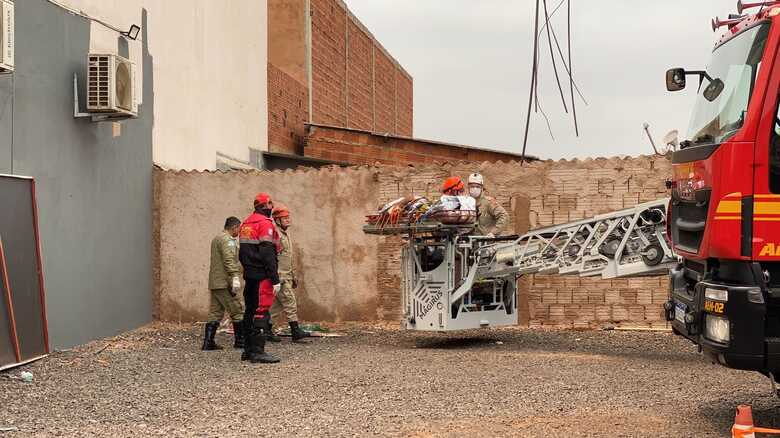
[364,199,677,332]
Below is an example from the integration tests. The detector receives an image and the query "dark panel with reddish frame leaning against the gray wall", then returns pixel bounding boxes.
[0,176,48,361]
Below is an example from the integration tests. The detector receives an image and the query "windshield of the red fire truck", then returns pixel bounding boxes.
[688,23,769,144]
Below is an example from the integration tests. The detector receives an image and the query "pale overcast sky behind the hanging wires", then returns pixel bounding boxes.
[346,0,736,159]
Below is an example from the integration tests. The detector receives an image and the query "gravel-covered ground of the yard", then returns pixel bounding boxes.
[0,325,780,438]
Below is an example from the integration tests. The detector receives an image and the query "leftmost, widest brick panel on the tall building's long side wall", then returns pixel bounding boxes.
[311,0,347,126]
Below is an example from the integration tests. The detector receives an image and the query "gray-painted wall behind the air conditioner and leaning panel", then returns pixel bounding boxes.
[0,0,154,348]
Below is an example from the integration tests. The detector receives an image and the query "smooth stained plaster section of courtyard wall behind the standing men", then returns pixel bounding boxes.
[154,168,381,321]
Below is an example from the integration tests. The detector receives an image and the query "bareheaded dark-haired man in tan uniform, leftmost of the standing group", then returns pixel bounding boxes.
[201,216,244,350]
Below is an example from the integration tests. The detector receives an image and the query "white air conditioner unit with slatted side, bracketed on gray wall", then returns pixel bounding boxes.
[87,54,138,116]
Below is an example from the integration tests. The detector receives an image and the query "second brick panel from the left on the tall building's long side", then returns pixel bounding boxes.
[347,20,374,131]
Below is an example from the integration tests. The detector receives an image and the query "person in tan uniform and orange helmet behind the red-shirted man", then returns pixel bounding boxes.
[268,205,307,344]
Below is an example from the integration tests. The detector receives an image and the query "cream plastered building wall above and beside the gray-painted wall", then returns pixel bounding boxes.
[58,0,268,169]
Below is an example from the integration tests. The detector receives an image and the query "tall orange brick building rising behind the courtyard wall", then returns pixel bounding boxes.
[268,0,414,153]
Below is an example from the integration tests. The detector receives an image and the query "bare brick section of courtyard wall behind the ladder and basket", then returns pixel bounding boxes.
[377,157,671,328]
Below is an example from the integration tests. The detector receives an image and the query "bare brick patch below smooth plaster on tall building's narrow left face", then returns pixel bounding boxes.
[268,64,309,155]
